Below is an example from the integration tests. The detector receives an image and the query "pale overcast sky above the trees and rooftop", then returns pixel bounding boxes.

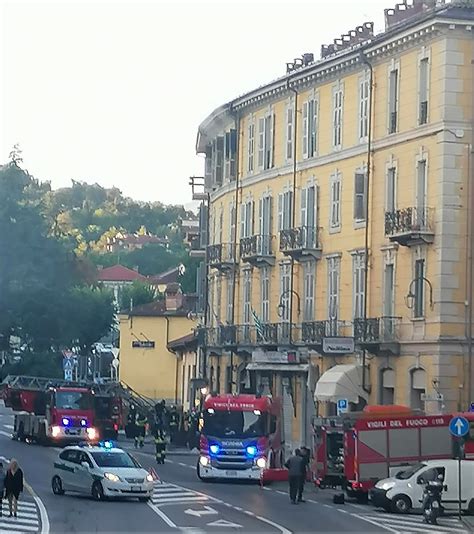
[0,0,386,208]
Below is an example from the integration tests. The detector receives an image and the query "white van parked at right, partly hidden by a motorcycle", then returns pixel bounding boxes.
[369,460,474,514]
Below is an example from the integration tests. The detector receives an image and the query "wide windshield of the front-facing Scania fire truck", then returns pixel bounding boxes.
[203,411,266,438]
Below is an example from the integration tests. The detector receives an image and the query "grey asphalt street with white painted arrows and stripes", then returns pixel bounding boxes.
[0,405,467,534]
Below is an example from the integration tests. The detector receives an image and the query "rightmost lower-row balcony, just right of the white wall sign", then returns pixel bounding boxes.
[354,317,401,356]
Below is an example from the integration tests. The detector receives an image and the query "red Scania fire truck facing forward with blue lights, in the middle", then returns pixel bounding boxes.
[197,395,283,481]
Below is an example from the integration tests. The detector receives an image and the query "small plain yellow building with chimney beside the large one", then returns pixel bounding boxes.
[119,284,200,404]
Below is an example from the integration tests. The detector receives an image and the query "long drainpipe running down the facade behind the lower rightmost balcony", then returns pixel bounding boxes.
[359,52,375,393]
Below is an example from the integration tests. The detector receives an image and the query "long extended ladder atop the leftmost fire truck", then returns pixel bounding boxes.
[0,375,155,410]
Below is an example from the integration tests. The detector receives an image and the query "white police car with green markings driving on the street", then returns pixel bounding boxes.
[51,442,154,502]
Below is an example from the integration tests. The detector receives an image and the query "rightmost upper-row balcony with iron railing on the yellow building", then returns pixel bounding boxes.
[385,207,434,247]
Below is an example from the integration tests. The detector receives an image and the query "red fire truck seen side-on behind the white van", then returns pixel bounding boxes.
[312,406,474,501]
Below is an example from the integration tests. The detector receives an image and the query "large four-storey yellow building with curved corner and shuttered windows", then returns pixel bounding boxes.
[195,0,474,452]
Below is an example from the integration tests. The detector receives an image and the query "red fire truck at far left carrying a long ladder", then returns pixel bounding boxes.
[2,376,98,444]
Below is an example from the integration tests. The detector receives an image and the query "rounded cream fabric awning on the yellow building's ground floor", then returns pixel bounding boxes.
[314,365,369,403]
